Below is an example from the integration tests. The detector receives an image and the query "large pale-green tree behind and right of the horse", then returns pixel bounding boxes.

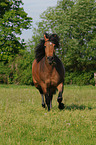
[29,0,96,84]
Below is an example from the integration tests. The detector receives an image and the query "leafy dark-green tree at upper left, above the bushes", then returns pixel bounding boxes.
[0,0,32,62]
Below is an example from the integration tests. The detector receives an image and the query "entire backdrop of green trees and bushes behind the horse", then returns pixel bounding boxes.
[0,0,96,85]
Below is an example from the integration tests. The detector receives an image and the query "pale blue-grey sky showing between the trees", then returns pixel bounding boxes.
[20,0,58,41]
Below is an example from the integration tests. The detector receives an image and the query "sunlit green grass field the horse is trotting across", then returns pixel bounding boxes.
[0,85,96,145]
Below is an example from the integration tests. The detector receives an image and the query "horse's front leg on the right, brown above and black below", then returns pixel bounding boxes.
[57,83,64,109]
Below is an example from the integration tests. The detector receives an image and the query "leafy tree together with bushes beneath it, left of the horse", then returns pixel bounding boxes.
[0,0,32,84]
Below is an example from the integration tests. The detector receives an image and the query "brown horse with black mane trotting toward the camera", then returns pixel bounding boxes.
[32,33,65,111]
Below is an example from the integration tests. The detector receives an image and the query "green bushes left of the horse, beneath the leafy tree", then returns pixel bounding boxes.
[0,48,34,85]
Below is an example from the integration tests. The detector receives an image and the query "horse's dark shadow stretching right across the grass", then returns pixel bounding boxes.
[58,103,93,110]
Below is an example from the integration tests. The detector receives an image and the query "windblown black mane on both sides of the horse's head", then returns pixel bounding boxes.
[35,33,59,62]
